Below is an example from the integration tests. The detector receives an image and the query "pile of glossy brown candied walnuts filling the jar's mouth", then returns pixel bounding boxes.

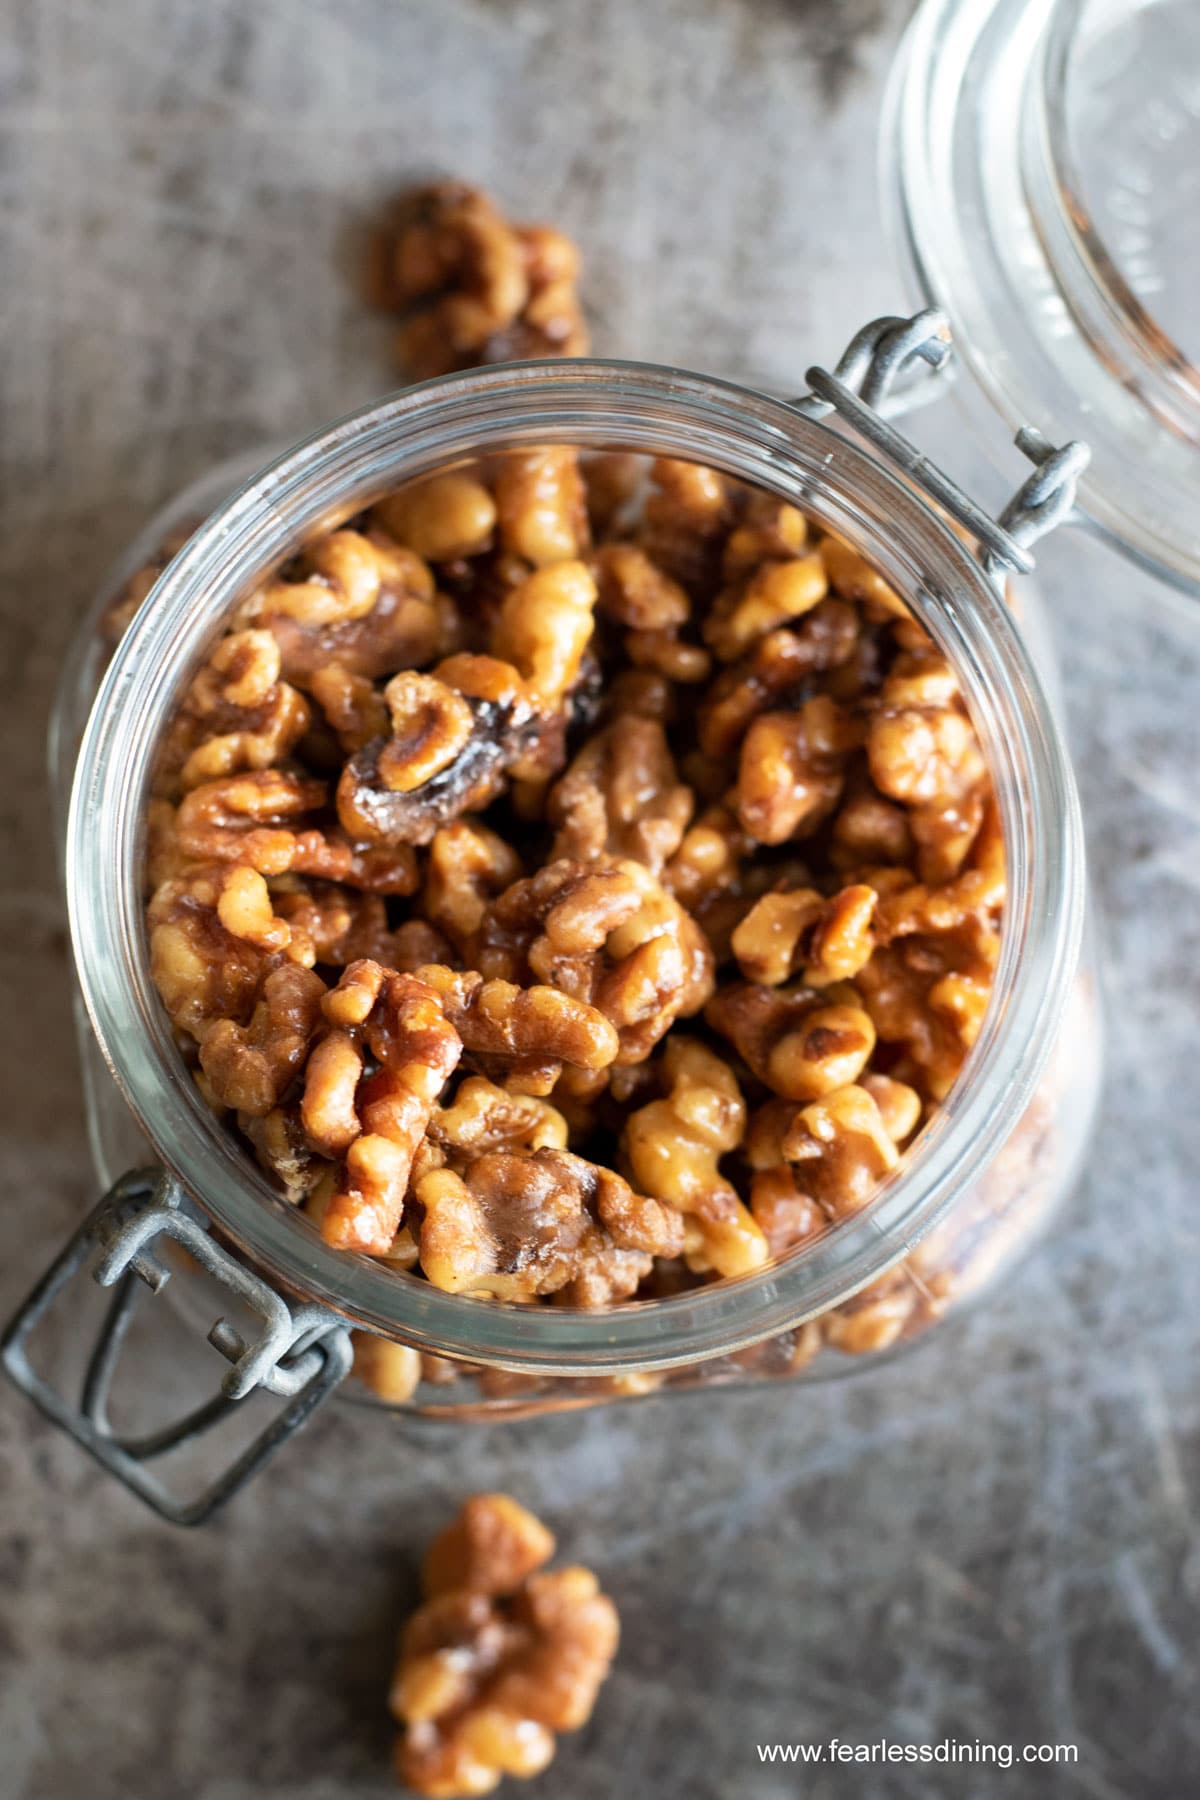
[135,428,1004,1348]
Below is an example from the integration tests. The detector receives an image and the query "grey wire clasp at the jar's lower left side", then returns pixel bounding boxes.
[0,1168,354,1525]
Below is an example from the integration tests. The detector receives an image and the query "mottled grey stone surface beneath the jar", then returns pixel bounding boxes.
[0,0,1200,1800]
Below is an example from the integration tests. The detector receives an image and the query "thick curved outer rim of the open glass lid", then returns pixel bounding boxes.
[880,0,1200,596]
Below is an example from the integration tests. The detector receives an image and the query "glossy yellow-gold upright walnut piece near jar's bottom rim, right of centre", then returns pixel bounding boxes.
[622,1037,768,1274]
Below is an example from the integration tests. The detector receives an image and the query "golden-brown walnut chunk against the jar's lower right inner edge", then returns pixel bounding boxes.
[747,1084,900,1220]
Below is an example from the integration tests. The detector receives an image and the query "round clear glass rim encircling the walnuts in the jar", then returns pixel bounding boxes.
[67,360,1083,1375]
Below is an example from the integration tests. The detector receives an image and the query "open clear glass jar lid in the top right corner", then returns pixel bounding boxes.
[883,0,1200,592]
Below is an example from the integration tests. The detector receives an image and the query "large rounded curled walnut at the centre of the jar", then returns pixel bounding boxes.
[471,859,712,1064]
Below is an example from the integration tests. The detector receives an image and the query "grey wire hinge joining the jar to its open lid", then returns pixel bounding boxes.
[792,306,1092,585]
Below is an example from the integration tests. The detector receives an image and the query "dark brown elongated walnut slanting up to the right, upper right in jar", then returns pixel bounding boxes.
[698,599,860,758]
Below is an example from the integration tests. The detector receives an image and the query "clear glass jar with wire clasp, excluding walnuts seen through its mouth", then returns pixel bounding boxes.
[9,347,1099,1521]
